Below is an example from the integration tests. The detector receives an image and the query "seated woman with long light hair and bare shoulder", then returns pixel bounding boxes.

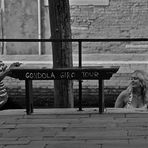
[115,70,148,108]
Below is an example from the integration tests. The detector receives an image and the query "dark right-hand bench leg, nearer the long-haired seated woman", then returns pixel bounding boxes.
[99,79,104,114]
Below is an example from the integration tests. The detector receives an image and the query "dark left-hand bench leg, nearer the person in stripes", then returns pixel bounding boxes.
[25,80,33,115]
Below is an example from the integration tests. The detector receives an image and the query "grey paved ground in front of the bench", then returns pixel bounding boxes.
[0,109,148,148]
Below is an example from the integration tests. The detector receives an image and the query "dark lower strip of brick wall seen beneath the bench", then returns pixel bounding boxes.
[4,80,125,108]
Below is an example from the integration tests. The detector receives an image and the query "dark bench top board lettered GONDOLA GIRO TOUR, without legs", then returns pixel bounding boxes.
[13,67,117,80]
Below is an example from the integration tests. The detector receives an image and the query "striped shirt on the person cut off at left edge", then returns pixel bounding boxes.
[0,62,8,107]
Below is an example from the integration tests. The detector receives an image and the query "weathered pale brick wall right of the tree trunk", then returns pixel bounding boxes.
[71,0,148,53]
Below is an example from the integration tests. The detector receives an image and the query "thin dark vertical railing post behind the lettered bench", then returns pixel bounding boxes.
[78,40,82,111]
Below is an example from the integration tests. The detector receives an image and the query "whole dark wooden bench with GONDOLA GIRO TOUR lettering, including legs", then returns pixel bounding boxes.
[12,66,119,115]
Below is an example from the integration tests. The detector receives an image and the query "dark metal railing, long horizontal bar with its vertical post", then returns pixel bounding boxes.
[0,38,148,111]
